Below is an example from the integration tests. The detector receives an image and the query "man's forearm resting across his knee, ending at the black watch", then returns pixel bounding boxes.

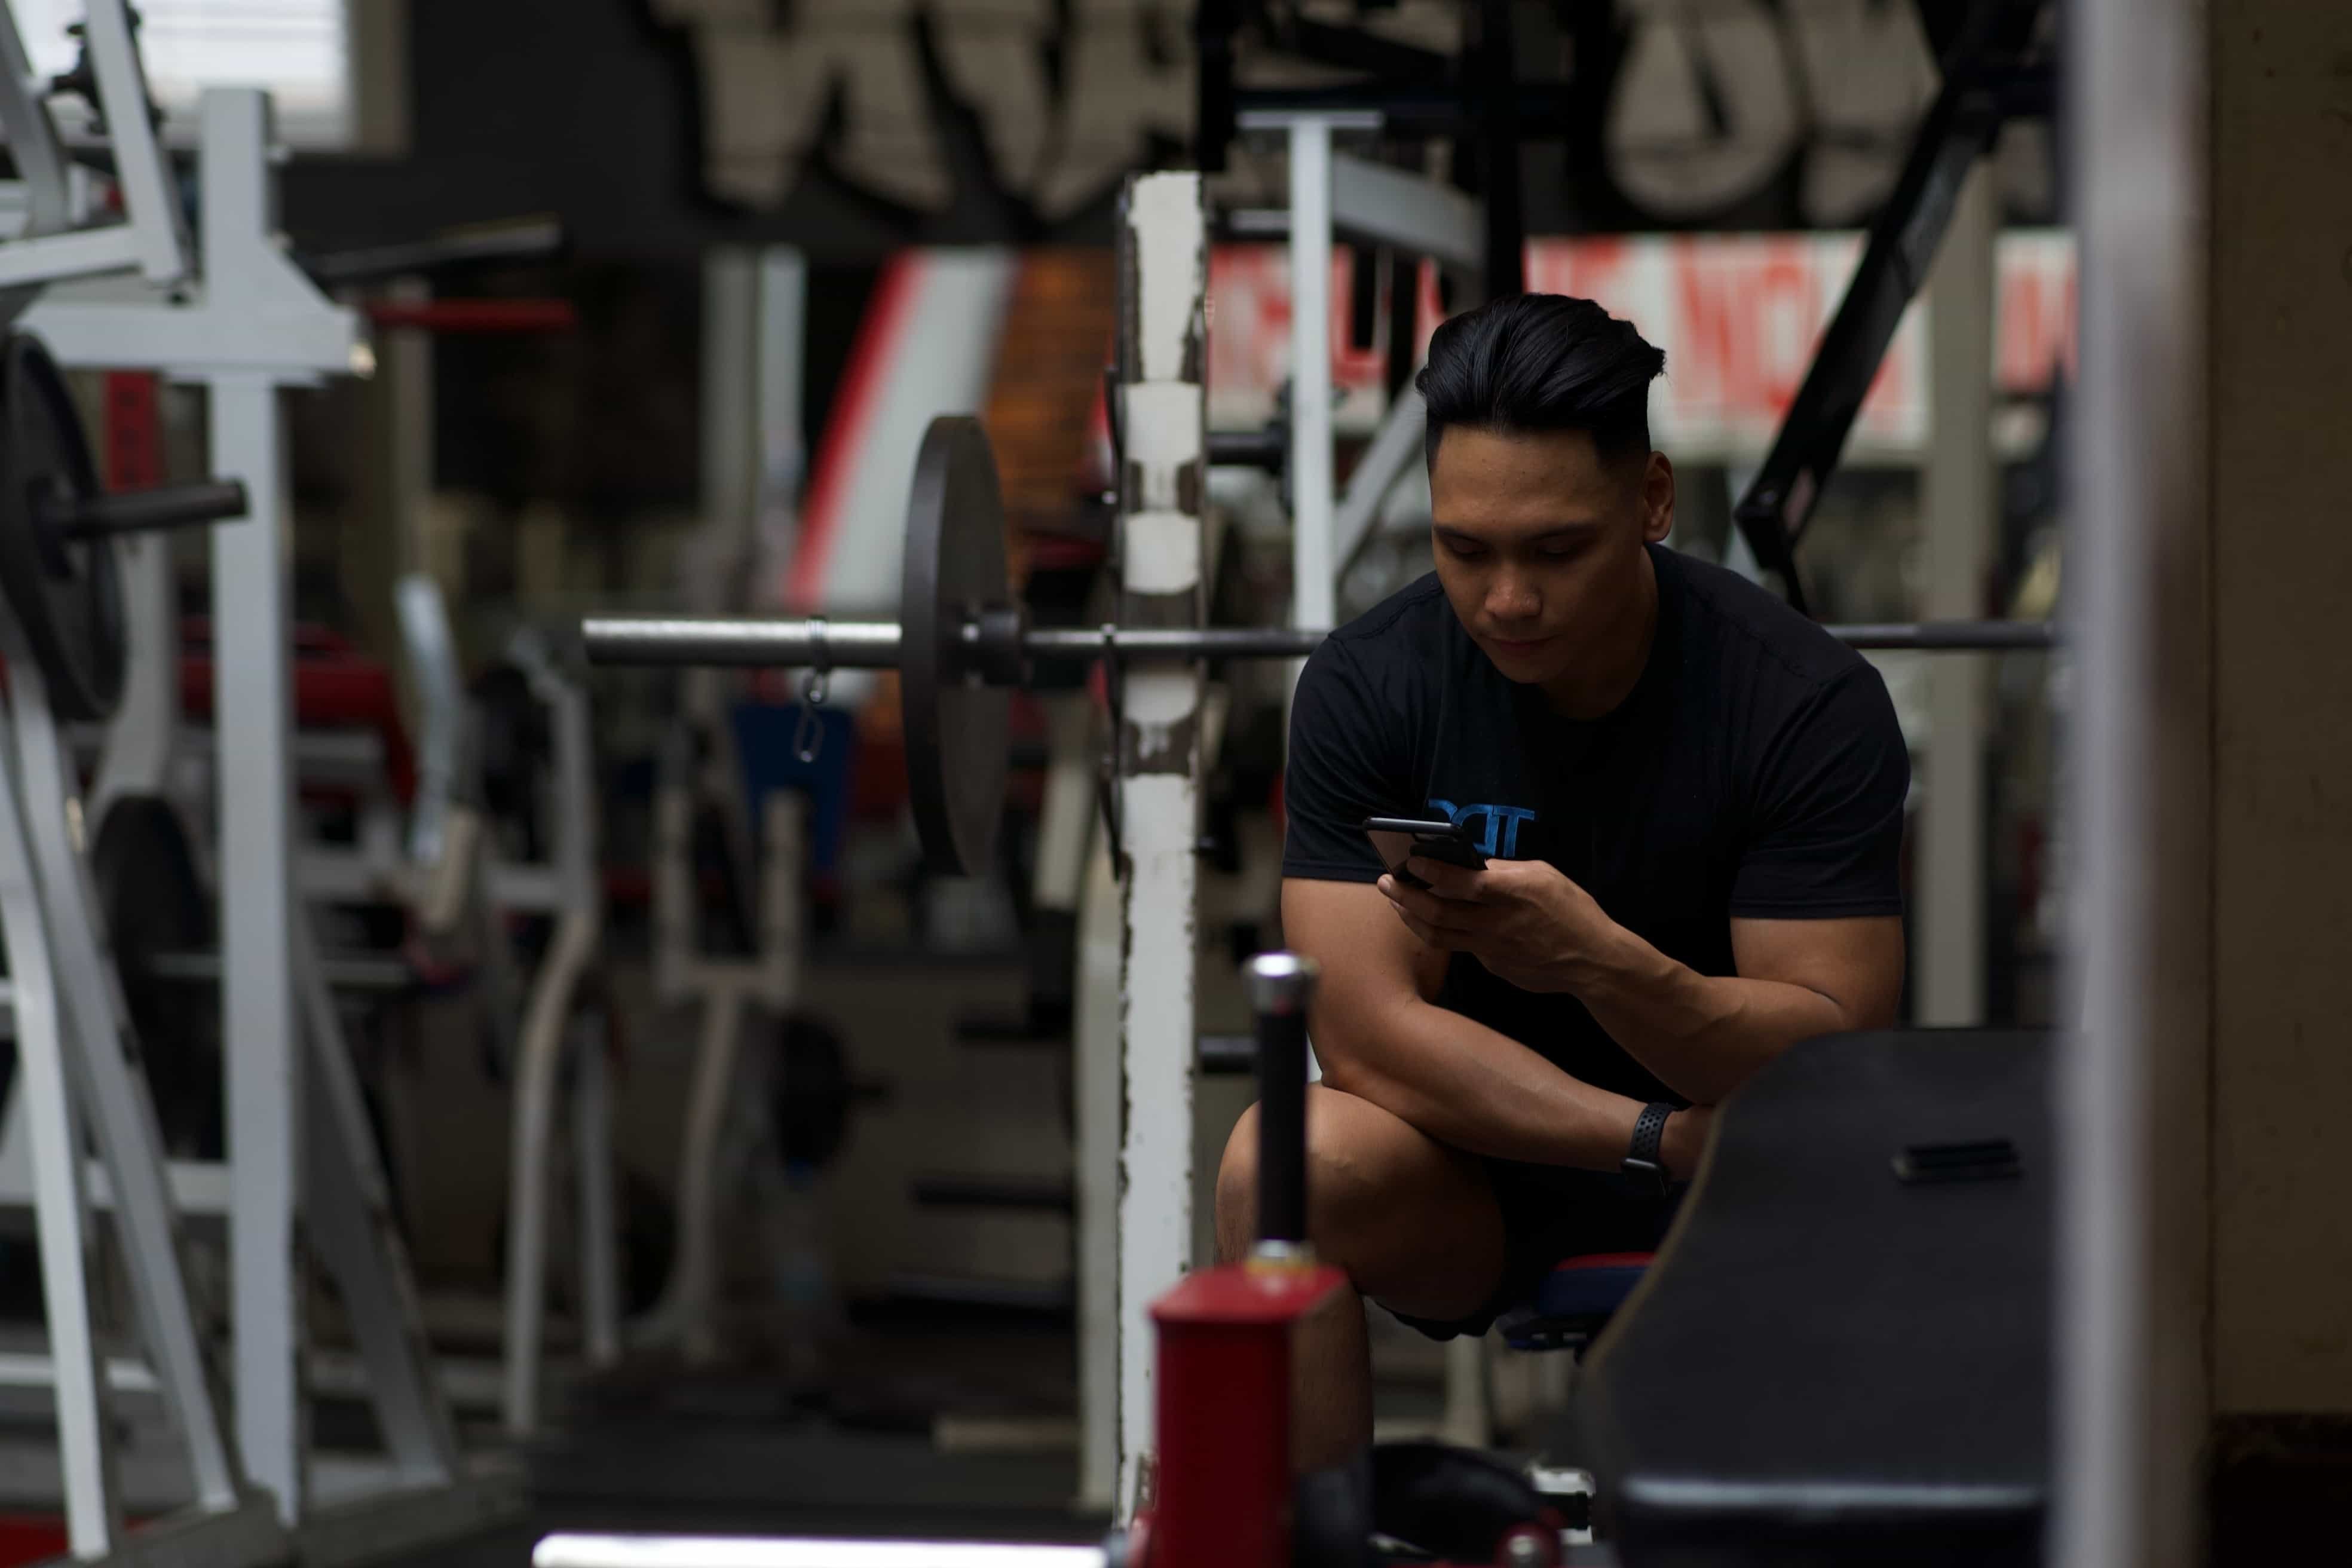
[1317,1002,1642,1171]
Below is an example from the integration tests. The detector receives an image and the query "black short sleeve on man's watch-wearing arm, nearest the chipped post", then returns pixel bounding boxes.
[1282,639,1407,881]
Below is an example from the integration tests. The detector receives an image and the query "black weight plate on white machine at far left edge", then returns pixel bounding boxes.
[0,332,125,719]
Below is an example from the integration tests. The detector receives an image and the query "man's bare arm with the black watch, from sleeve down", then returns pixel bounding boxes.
[1282,879,1655,1175]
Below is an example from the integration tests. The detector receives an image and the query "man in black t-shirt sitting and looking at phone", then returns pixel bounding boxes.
[1216,294,1910,1467]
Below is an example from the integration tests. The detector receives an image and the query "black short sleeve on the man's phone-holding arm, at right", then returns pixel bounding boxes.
[1731,665,1910,919]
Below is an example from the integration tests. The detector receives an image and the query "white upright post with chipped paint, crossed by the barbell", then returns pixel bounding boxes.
[1115,174,1204,1514]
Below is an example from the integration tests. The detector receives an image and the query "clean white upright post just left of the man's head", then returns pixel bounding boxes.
[1279,115,1339,627]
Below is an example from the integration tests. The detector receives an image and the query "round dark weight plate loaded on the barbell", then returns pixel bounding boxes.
[899,414,1011,877]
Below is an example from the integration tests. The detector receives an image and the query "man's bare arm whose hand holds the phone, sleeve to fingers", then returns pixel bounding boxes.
[1378,858,1903,1105]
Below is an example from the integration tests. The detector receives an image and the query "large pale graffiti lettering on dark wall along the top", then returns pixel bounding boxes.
[651,0,2048,232]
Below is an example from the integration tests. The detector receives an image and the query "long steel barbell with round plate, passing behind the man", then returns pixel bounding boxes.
[581,416,2051,877]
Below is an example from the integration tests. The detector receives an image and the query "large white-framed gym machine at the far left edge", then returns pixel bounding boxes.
[0,0,517,1563]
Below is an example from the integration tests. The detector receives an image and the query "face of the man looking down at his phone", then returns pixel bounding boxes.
[1430,425,1674,687]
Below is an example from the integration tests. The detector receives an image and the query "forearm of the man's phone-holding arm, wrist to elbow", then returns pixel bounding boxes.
[1571,926,1854,1105]
